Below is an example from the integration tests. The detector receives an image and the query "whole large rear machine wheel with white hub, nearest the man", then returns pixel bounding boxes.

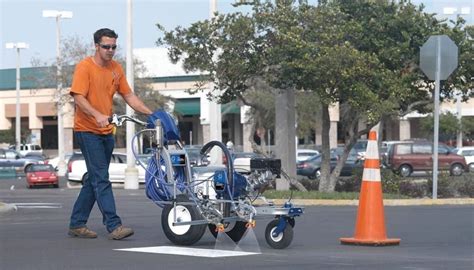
[161,195,206,246]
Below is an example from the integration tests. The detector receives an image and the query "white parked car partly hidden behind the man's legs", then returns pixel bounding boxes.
[67,153,145,184]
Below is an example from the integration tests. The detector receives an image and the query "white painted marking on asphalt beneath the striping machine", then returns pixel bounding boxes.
[114,246,261,258]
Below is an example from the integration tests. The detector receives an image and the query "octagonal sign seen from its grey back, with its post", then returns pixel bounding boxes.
[420,35,458,199]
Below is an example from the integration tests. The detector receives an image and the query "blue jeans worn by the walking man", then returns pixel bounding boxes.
[69,132,122,232]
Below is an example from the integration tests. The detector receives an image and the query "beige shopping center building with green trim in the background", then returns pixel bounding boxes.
[0,48,474,153]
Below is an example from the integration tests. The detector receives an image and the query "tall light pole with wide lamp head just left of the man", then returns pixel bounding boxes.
[43,10,72,176]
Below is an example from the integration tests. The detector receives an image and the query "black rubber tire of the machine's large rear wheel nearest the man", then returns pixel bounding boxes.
[161,194,206,246]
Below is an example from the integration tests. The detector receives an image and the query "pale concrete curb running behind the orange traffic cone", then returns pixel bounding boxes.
[269,198,474,206]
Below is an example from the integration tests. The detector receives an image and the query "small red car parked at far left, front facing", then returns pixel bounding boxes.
[26,164,59,188]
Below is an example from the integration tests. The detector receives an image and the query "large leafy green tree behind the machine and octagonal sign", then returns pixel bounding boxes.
[159,0,473,192]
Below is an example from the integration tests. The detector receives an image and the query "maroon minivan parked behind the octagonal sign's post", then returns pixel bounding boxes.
[388,141,468,177]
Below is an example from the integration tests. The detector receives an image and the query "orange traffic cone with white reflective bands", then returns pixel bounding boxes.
[340,126,400,246]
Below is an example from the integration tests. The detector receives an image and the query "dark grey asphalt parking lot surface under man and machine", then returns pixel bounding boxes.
[0,175,474,269]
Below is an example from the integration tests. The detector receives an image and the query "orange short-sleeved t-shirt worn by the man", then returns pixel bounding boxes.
[70,57,132,134]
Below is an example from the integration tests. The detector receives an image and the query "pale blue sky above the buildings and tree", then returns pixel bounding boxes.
[0,0,474,69]
